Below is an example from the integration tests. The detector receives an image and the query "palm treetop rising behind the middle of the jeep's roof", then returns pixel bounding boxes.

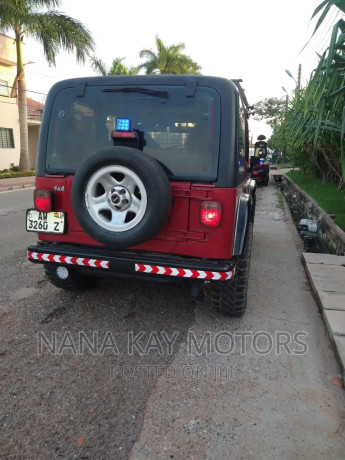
[139,36,201,75]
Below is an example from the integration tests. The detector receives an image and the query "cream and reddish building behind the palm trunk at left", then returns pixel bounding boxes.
[0,34,43,170]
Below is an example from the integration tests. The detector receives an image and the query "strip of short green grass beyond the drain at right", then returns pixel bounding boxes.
[287,171,345,231]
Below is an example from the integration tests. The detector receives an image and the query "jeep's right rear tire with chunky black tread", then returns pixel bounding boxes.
[211,221,253,317]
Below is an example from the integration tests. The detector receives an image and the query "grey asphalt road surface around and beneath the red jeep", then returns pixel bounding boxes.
[0,183,345,460]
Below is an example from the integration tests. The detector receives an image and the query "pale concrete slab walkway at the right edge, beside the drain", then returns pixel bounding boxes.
[302,253,345,384]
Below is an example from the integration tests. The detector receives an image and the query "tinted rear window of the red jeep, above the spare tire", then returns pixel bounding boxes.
[46,85,220,180]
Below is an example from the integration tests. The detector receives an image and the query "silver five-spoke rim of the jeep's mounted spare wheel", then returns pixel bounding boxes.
[85,165,147,232]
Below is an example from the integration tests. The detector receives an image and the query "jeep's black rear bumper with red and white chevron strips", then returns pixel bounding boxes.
[27,244,235,281]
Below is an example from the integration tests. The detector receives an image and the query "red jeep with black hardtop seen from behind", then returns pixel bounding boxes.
[27,75,255,316]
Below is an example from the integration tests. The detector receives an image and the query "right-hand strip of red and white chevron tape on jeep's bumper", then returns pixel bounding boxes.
[135,264,235,281]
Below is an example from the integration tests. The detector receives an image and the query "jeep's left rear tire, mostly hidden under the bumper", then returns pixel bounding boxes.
[44,264,97,291]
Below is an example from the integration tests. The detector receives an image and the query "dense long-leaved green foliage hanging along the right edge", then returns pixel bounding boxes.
[271,0,345,187]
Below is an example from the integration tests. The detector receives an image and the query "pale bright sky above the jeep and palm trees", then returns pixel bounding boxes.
[20,0,340,139]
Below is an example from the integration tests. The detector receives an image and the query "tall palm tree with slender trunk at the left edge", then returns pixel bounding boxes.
[0,0,94,171]
